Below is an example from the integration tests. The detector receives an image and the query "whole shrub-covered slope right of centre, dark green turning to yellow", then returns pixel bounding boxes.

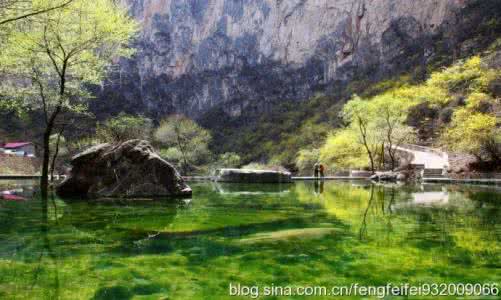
[204,51,501,175]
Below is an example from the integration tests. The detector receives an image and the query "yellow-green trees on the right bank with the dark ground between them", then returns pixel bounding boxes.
[320,56,501,170]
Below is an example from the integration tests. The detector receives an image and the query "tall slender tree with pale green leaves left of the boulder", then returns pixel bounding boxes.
[0,0,137,199]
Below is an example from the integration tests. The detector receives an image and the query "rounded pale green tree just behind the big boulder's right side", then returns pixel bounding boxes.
[154,115,211,174]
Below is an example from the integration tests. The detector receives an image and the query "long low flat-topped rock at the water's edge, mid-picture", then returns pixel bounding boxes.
[216,169,292,183]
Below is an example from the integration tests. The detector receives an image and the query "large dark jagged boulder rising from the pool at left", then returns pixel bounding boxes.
[57,140,191,198]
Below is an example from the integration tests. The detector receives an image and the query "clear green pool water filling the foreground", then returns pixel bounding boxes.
[0,182,501,299]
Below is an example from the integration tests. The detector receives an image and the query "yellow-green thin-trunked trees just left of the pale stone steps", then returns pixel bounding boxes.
[320,91,417,169]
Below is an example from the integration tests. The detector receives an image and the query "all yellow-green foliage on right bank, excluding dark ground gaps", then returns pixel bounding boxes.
[320,56,501,168]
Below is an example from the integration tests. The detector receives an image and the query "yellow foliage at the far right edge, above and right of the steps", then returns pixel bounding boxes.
[395,56,501,157]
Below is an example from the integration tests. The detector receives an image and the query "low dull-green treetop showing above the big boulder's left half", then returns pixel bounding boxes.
[96,113,153,143]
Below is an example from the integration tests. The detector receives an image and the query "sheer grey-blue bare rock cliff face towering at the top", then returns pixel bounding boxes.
[95,0,465,118]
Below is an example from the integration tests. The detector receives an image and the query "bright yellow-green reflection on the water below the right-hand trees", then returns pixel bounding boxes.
[296,183,500,242]
